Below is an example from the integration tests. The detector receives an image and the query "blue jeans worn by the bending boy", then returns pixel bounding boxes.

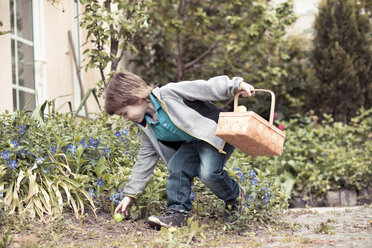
[166,141,239,212]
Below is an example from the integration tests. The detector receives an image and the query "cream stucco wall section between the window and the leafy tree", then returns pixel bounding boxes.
[45,1,99,112]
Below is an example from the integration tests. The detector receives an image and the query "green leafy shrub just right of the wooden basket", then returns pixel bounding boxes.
[252,109,372,203]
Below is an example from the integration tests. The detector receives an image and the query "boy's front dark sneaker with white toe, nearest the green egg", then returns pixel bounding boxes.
[147,210,189,229]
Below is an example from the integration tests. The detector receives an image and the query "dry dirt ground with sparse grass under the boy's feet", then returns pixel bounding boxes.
[0,205,372,248]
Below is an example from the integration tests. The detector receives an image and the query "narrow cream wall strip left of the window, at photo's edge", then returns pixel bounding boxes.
[0,1,13,113]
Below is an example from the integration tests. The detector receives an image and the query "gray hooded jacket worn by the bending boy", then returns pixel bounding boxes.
[124,76,243,198]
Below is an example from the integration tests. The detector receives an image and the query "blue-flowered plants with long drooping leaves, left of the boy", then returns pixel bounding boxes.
[0,108,139,217]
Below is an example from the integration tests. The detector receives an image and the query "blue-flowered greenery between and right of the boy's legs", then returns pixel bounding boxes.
[190,149,287,230]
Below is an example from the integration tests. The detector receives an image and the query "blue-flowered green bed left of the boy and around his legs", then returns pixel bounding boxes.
[0,107,282,221]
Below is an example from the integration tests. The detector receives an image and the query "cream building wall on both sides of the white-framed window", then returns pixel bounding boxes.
[0,0,100,112]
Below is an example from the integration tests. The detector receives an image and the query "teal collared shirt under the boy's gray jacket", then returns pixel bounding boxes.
[145,94,198,143]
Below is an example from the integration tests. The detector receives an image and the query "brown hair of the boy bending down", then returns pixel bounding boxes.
[105,71,152,115]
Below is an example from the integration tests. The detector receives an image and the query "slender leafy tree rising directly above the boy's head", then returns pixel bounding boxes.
[79,0,151,95]
